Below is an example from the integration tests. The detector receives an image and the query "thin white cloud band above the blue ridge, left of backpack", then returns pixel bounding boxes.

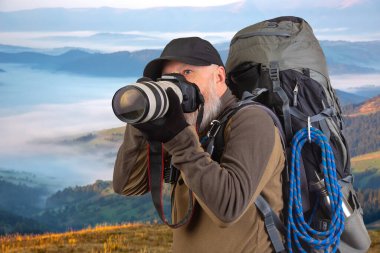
[0,31,235,52]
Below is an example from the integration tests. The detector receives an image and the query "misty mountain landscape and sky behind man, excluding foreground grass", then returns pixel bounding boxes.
[0,0,380,252]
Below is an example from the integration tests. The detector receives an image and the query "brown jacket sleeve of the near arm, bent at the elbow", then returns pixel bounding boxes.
[164,107,284,227]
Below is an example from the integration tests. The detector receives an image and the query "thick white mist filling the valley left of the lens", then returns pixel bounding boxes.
[0,100,124,187]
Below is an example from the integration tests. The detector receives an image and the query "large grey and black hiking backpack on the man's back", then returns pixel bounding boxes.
[208,17,371,252]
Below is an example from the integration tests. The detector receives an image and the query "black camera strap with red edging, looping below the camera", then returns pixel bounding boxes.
[148,141,195,228]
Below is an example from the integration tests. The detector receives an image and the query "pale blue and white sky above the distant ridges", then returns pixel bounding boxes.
[0,0,380,52]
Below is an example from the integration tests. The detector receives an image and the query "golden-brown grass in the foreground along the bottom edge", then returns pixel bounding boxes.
[0,224,380,253]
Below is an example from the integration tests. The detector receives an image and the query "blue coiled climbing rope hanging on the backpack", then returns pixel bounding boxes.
[287,127,344,252]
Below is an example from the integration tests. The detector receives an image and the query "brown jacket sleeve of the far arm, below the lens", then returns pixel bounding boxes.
[113,124,149,195]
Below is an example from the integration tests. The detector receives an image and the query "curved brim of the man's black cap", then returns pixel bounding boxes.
[144,56,211,80]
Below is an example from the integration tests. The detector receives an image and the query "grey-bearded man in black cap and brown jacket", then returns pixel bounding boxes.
[113,37,285,252]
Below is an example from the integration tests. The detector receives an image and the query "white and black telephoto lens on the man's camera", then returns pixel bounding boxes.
[112,81,183,124]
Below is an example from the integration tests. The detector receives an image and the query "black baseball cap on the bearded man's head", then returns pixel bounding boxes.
[144,37,224,80]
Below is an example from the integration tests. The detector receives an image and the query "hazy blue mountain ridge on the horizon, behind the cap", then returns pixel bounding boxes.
[0,39,380,77]
